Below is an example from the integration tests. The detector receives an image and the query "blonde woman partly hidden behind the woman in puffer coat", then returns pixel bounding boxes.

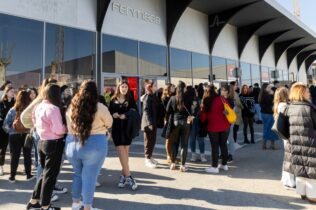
[273,87,295,188]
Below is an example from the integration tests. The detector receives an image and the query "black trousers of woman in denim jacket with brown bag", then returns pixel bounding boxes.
[9,133,32,178]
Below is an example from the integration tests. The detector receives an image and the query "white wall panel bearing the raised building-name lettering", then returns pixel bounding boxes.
[102,0,167,45]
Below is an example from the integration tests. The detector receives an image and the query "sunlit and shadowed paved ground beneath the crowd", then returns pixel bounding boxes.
[0,125,316,210]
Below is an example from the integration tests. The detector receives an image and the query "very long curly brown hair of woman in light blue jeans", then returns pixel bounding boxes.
[70,80,98,145]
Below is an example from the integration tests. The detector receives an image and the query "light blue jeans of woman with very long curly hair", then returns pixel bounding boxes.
[66,134,108,206]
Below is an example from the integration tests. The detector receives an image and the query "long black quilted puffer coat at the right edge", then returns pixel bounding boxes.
[284,102,316,179]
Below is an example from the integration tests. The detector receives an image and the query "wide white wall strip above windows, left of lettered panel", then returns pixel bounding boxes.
[0,0,97,31]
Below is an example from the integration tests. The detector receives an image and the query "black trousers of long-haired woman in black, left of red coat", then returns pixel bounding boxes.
[171,120,190,165]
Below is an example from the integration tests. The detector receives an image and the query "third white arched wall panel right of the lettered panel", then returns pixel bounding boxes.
[240,35,260,65]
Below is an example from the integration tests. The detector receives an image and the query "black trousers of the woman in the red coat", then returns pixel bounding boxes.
[209,129,229,168]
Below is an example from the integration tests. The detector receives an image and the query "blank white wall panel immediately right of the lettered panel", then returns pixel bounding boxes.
[170,8,210,54]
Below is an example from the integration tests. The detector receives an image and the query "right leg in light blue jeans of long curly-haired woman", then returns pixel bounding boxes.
[79,135,108,208]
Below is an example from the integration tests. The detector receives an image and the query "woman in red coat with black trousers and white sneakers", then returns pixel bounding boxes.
[200,85,230,173]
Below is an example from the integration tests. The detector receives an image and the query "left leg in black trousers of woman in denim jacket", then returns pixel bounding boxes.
[9,134,23,179]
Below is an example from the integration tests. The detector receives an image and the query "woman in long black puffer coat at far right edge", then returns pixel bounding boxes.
[284,83,316,202]
